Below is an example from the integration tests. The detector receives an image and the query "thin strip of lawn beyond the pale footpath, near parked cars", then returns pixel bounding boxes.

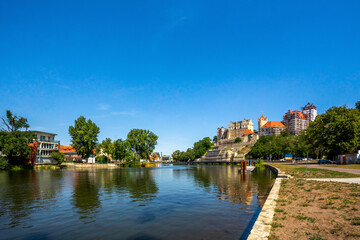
[270,163,360,178]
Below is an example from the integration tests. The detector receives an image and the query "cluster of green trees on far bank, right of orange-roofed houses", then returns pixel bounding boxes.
[69,116,158,161]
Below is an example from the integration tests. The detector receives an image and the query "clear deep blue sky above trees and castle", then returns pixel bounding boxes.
[0,0,360,154]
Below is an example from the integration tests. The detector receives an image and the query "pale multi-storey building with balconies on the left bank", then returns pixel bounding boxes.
[32,131,60,164]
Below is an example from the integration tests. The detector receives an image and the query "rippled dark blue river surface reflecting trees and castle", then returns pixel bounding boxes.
[0,165,275,239]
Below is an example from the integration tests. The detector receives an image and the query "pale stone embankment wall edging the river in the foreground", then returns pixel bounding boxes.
[248,165,288,240]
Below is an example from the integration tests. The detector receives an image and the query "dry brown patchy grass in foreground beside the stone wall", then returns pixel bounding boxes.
[269,179,360,240]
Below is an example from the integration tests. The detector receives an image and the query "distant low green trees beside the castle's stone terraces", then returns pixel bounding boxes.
[172,137,212,161]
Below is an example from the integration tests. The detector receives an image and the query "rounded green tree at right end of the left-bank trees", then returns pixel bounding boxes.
[127,129,158,159]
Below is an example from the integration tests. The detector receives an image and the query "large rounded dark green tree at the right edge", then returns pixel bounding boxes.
[307,106,360,158]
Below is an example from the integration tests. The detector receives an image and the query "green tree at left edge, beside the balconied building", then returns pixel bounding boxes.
[0,110,35,164]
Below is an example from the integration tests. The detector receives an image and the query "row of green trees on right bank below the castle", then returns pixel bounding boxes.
[249,101,360,159]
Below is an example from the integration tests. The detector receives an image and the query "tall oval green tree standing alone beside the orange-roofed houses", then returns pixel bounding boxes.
[69,116,100,159]
